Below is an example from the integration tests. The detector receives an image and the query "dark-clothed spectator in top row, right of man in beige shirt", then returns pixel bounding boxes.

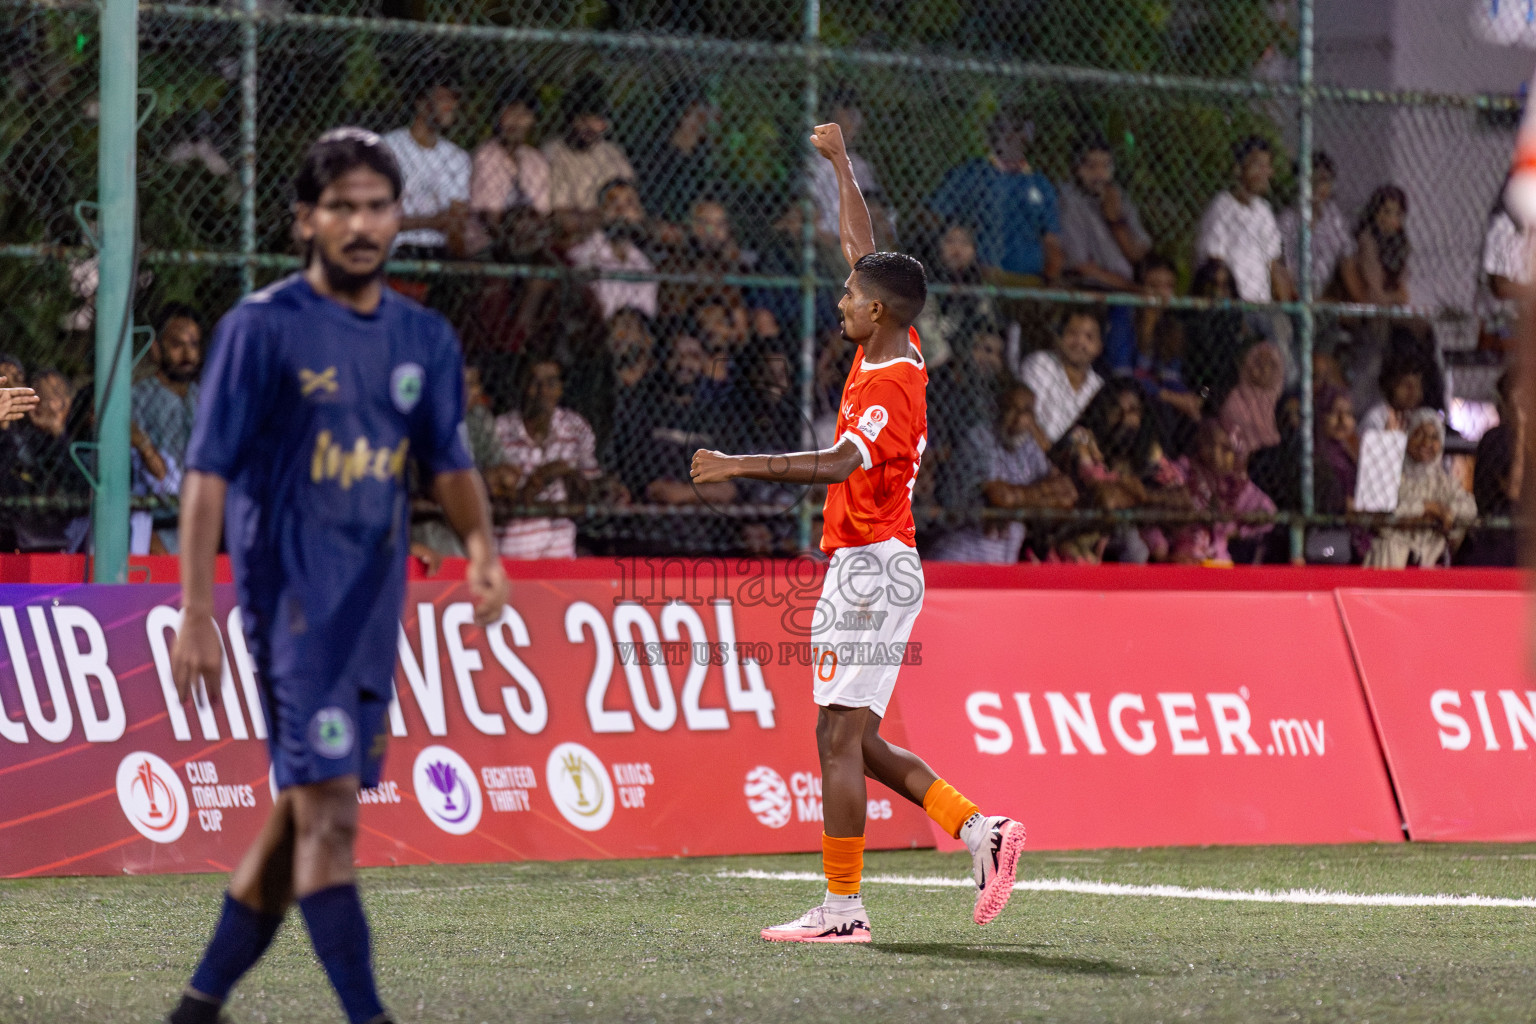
[634,78,724,230]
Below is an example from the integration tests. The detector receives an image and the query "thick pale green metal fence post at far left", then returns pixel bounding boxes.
[91,0,138,583]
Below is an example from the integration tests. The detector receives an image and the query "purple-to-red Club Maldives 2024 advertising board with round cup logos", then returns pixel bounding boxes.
[0,571,931,877]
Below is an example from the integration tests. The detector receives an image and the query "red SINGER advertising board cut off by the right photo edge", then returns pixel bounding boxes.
[1338,591,1536,841]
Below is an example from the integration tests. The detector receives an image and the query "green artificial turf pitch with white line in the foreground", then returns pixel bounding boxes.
[9,844,1536,1024]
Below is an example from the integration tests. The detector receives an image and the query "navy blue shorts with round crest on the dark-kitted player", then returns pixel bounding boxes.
[261,679,389,789]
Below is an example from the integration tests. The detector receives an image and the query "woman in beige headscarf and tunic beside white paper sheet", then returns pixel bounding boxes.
[1366,408,1478,570]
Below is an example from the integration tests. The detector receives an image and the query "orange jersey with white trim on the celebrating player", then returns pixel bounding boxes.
[822,329,928,554]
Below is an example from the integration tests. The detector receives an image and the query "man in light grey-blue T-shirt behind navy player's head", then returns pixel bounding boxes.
[384,74,472,259]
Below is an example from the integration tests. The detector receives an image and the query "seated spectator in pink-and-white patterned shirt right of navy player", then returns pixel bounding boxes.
[496,359,602,559]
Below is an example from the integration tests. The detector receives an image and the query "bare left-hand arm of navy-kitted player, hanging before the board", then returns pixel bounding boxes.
[170,470,229,703]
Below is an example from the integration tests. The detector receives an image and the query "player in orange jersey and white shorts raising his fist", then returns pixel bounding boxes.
[693,124,1025,943]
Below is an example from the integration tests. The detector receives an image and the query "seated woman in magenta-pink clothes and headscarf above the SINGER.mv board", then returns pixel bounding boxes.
[1167,419,1275,565]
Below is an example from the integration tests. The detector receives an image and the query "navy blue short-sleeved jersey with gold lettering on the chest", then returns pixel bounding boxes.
[186,275,473,700]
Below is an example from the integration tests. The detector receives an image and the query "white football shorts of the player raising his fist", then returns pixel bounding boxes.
[811,537,923,718]
